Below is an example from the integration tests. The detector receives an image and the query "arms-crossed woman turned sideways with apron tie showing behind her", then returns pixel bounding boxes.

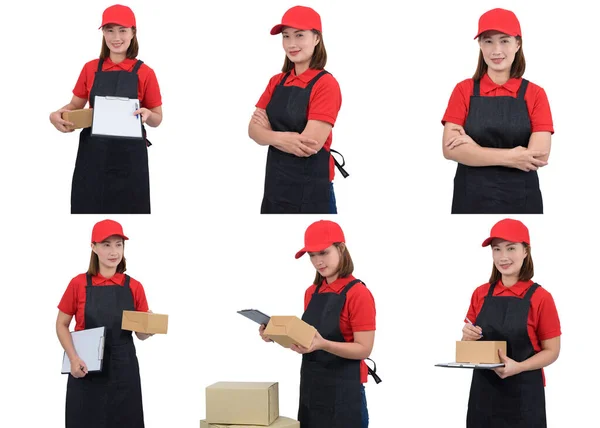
[248,6,348,214]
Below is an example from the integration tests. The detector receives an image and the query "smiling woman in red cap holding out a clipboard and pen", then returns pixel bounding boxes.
[50,5,162,214]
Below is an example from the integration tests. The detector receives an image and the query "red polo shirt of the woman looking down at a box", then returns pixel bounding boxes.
[304,275,375,383]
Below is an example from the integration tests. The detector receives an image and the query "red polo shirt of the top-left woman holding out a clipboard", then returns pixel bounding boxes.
[73,58,162,109]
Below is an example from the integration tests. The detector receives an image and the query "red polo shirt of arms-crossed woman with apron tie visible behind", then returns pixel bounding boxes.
[256,68,342,181]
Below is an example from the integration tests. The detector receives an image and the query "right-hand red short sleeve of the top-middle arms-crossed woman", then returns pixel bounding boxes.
[308,74,342,126]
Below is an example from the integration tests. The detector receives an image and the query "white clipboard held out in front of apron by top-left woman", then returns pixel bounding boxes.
[91,95,144,139]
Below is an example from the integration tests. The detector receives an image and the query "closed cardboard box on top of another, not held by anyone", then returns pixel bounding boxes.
[206,382,279,426]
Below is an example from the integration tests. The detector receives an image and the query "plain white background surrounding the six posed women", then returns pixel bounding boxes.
[0,0,600,428]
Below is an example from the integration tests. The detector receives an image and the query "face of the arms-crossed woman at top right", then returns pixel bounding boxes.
[479,31,521,73]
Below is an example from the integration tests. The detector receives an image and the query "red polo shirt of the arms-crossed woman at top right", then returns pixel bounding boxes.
[442,74,554,133]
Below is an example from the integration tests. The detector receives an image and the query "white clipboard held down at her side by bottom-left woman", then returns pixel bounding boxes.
[61,327,106,374]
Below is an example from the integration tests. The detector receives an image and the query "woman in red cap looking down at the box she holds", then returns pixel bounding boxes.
[259,220,380,428]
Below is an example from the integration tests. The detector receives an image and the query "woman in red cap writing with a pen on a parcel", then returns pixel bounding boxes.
[462,219,561,428]
